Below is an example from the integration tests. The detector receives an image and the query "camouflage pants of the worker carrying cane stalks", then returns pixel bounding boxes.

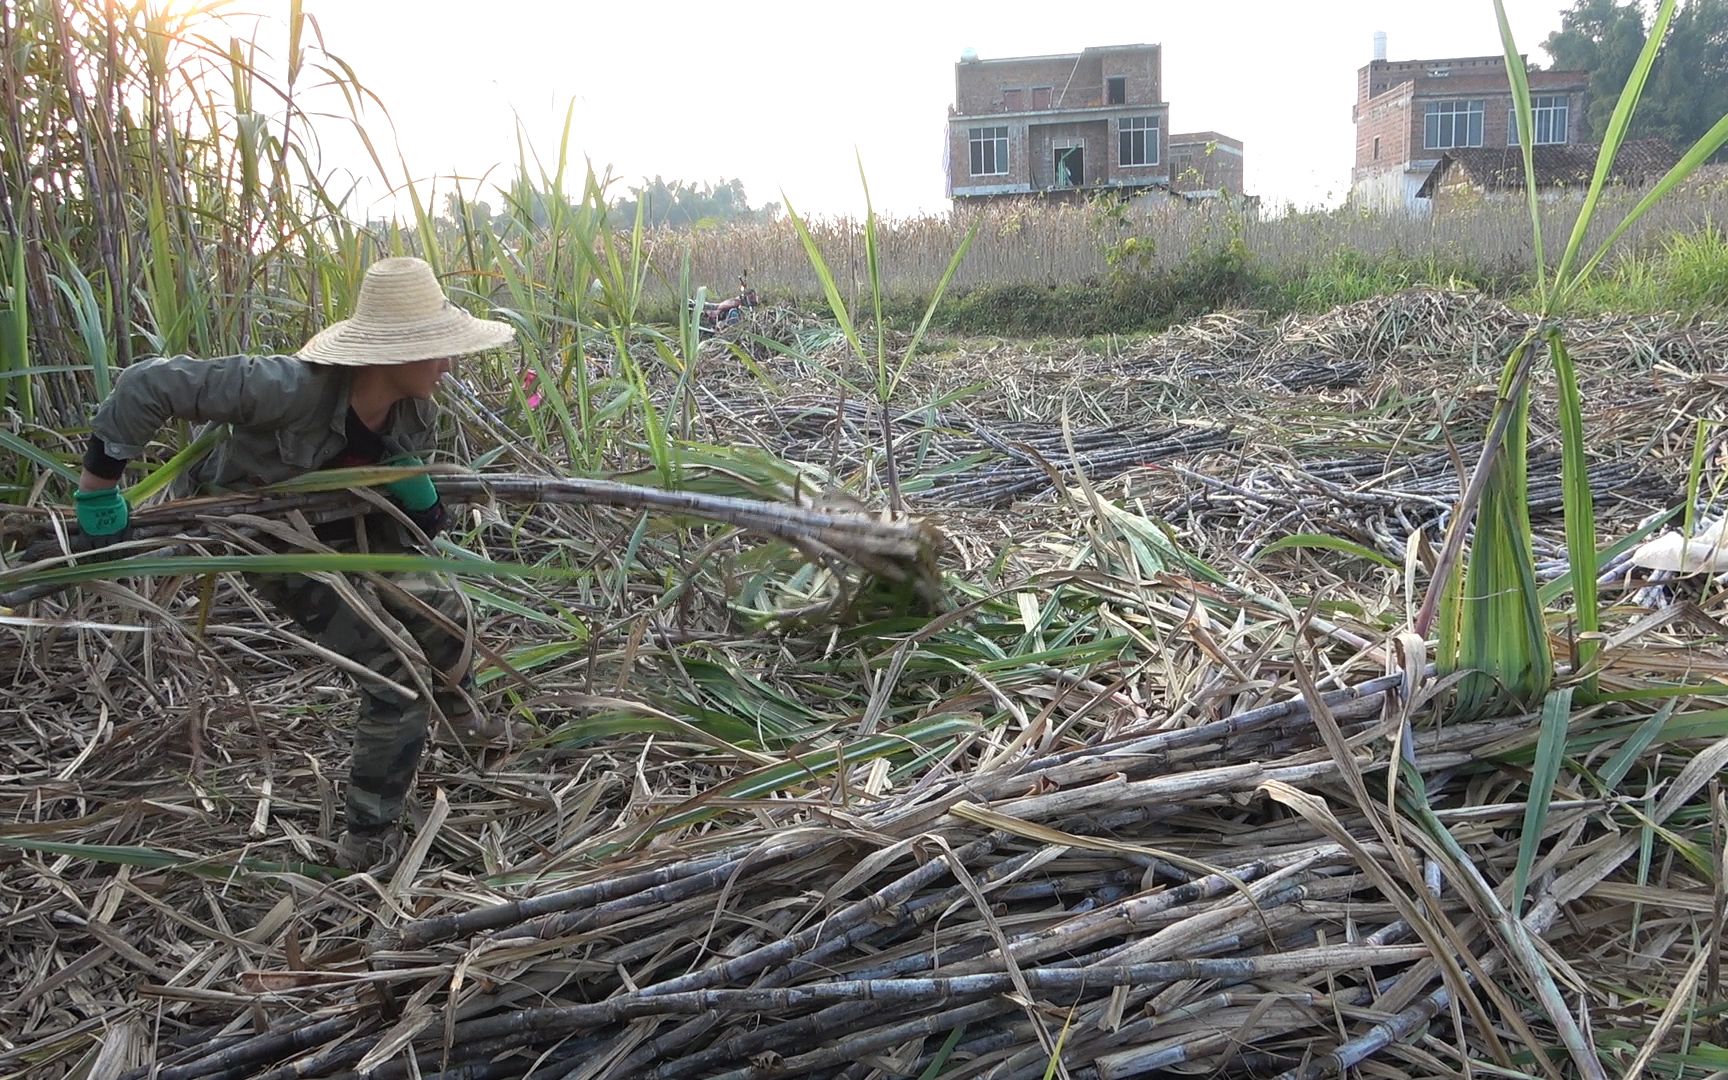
[247,559,472,829]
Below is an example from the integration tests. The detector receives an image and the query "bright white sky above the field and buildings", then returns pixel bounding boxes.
[249,0,1569,216]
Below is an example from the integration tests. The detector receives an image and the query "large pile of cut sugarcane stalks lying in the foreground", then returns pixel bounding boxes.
[94,676,1707,1080]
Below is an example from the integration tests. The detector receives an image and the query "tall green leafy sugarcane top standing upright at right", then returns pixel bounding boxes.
[1415,0,1728,714]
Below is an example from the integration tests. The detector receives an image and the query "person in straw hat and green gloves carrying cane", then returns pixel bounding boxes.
[76,259,522,873]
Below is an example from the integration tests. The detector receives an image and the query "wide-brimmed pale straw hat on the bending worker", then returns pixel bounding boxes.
[297,259,515,366]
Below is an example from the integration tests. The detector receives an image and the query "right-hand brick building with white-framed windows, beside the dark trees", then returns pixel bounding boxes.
[1350,35,1590,211]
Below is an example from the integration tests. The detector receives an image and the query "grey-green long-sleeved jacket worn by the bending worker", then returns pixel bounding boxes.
[92,356,437,492]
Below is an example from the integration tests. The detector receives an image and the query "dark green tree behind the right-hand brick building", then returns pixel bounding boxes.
[1543,0,1728,150]
